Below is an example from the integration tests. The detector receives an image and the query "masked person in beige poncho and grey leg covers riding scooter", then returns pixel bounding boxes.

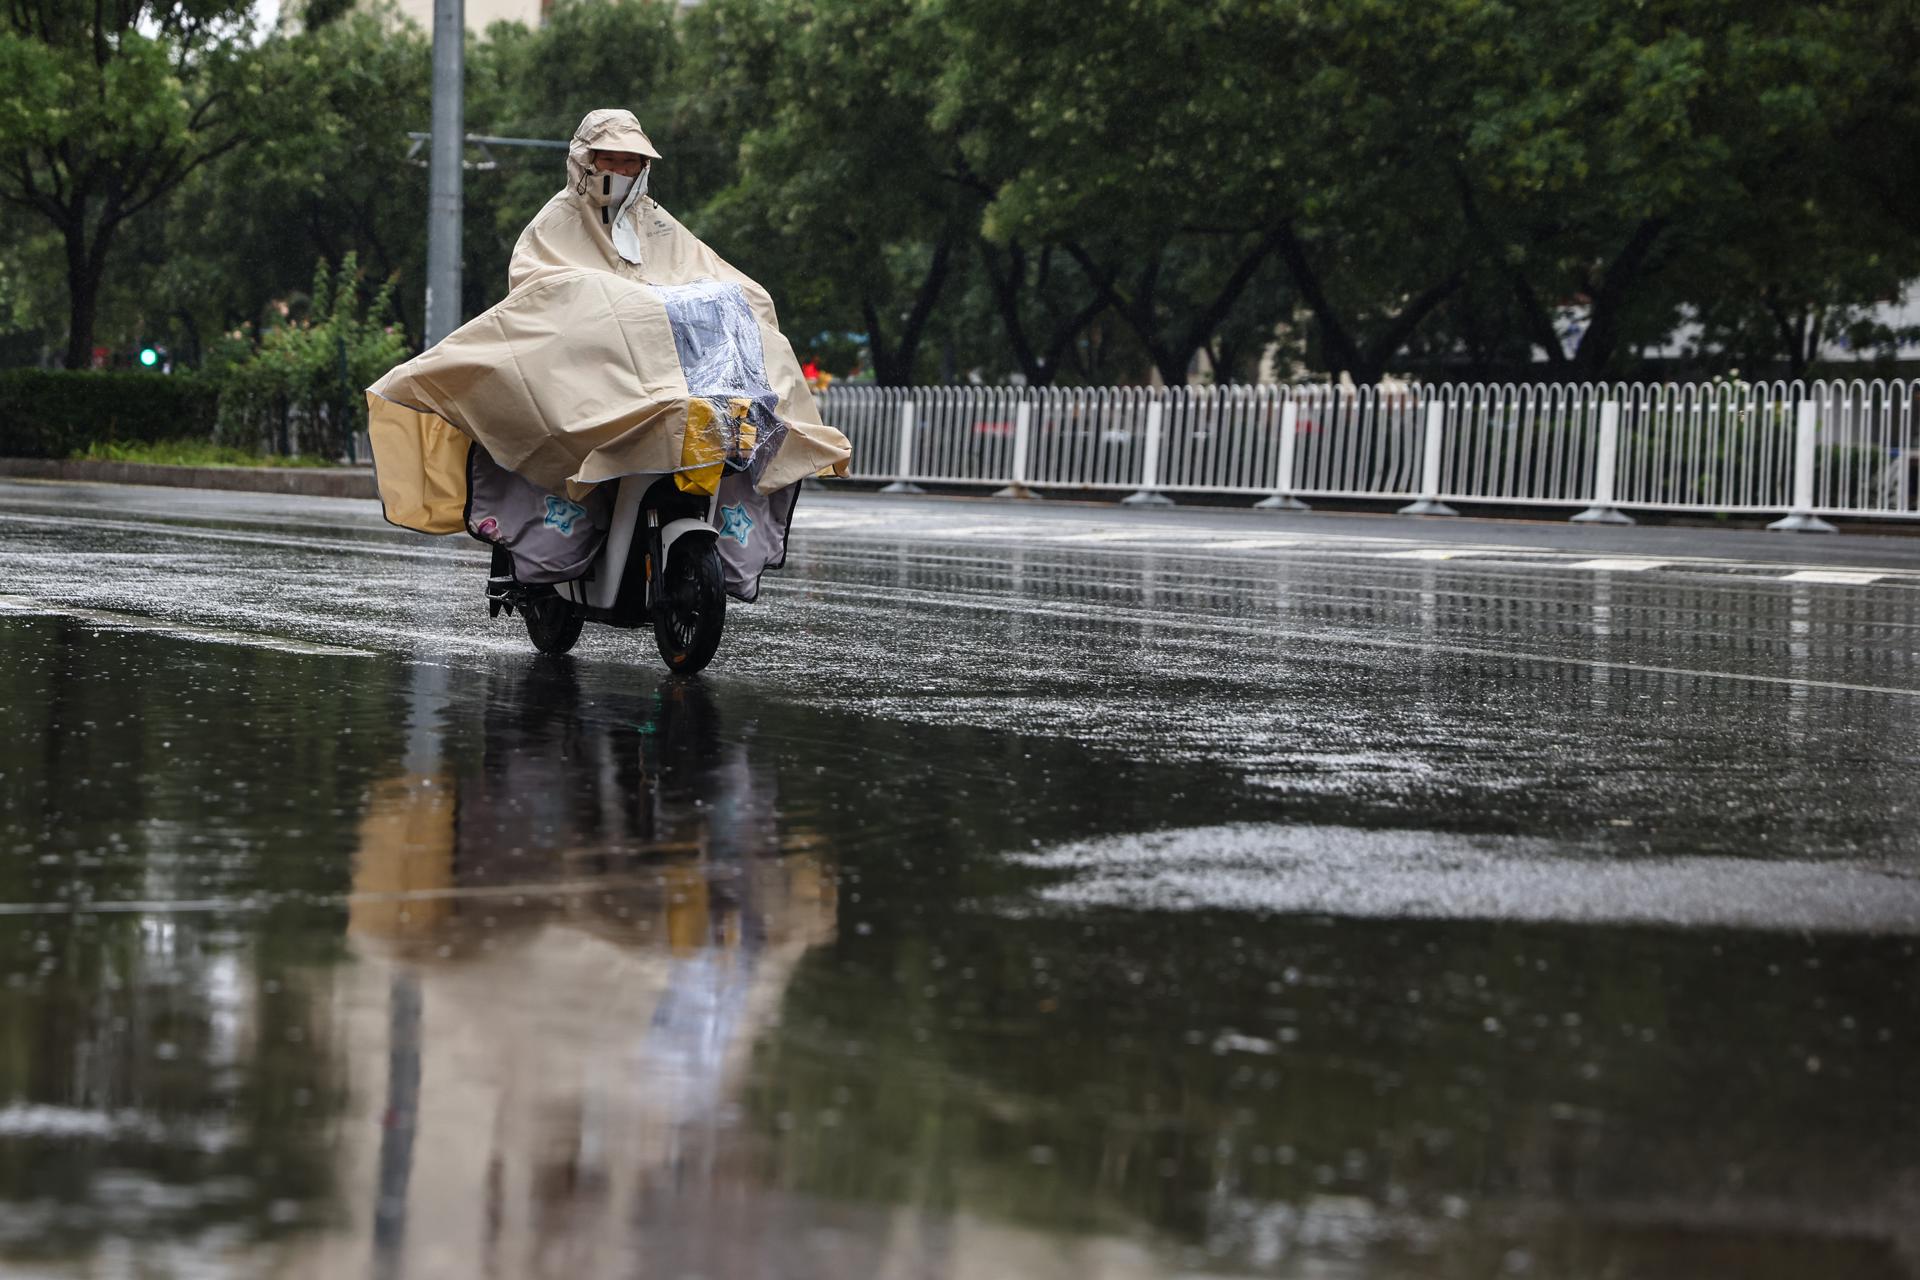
[369,109,851,671]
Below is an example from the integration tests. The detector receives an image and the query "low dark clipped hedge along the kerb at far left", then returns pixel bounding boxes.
[0,368,219,459]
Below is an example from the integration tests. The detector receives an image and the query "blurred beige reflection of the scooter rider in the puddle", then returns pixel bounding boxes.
[293,660,835,1276]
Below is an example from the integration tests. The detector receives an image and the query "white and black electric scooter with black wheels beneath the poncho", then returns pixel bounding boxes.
[486,474,726,674]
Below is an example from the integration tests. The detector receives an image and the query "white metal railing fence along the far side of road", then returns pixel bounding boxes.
[820,380,1920,528]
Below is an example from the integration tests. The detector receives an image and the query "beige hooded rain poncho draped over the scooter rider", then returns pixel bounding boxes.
[367,111,851,533]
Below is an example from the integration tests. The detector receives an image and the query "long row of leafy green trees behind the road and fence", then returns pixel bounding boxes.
[0,0,1920,384]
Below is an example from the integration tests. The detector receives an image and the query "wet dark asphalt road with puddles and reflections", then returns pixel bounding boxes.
[0,484,1920,1280]
